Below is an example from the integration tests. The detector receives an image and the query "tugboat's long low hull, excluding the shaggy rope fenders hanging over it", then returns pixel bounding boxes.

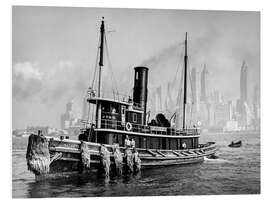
[27,138,217,179]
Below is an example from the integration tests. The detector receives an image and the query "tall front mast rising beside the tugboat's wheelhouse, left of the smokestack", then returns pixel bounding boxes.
[96,17,105,128]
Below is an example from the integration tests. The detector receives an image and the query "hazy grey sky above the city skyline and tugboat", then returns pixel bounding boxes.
[12,6,260,129]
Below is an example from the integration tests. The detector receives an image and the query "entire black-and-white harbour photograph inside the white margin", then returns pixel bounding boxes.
[10,5,261,198]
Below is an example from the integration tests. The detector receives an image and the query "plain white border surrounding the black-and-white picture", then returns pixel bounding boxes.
[0,0,270,203]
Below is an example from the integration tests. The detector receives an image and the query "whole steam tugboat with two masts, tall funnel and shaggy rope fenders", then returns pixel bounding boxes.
[26,19,217,177]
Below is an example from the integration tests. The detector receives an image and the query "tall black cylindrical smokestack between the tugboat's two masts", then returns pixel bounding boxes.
[133,66,148,125]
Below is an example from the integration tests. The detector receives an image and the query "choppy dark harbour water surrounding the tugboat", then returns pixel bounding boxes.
[12,134,260,198]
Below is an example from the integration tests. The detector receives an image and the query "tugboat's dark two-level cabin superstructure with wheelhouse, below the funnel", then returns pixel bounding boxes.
[88,96,199,150]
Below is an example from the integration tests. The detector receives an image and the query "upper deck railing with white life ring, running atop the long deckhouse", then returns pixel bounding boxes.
[98,119,200,136]
